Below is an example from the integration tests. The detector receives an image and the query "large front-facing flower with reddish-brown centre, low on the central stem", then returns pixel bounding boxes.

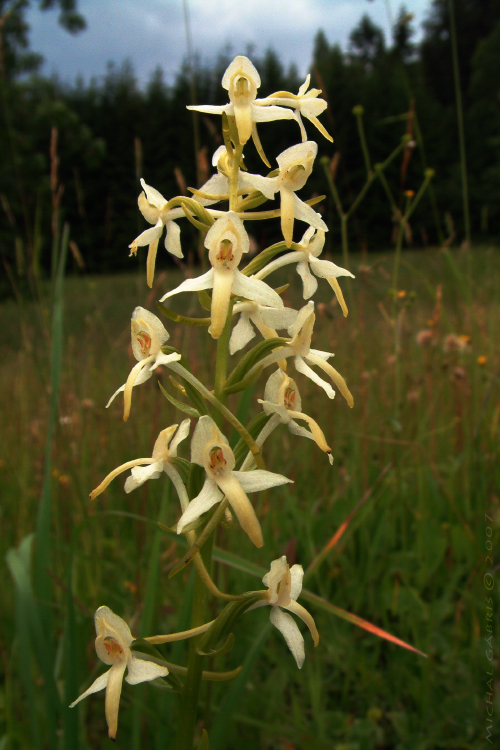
[177,416,292,547]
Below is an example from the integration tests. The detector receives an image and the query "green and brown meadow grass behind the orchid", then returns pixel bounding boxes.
[0,247,500,750]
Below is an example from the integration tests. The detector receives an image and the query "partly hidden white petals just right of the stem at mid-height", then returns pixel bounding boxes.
[229,302,298,354]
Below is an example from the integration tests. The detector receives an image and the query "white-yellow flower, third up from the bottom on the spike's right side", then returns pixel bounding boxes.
[244,302,354,408]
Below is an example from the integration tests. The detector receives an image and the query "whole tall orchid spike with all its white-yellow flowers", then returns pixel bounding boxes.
[72,56,353,747]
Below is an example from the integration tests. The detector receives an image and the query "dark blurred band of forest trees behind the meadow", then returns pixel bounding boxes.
[0,0,500,288]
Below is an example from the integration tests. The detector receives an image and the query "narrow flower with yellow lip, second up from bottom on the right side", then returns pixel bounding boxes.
[258,368,333,464]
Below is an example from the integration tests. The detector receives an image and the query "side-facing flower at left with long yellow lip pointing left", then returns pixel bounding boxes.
[90,419,191,500]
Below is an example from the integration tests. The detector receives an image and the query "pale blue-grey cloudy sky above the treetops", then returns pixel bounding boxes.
[27,0,430,85]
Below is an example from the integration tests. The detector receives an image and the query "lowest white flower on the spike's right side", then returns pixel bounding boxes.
[252,555,319,669]
